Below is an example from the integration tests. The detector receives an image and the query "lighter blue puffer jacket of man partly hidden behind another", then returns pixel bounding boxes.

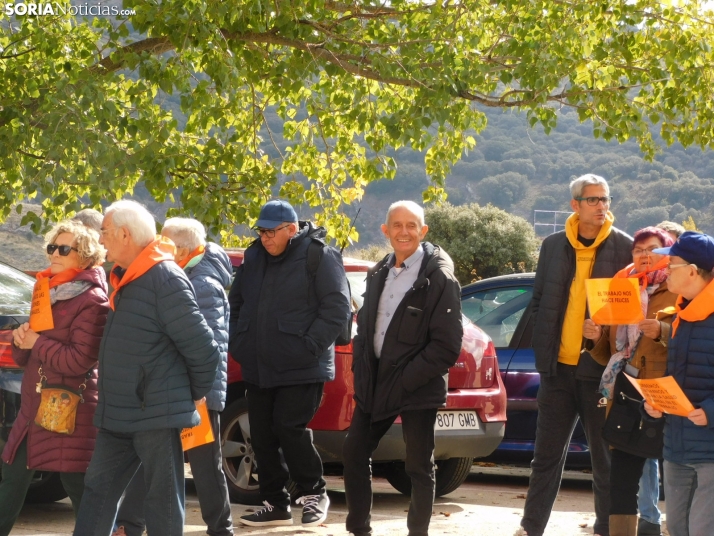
[186,242,232,411]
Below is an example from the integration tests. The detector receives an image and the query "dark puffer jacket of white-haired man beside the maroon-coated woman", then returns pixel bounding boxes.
[94,261,220,433]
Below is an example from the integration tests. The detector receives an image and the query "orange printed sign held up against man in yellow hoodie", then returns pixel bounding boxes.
[585,277,645,326]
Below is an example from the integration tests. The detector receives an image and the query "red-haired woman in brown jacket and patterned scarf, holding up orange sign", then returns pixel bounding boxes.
[583,227,677,536]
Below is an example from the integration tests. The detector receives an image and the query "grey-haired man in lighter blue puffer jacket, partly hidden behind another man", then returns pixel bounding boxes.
[114,218,233,536]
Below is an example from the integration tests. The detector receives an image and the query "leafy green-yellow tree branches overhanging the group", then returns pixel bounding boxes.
[0,0,714,240]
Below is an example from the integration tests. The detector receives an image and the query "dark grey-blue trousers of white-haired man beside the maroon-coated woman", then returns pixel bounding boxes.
[74,428,185,536]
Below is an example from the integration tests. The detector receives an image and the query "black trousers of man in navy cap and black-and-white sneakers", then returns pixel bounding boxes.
[246,383,326,508]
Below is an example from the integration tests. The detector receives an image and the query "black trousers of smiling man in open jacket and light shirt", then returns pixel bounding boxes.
[342,406,437,536]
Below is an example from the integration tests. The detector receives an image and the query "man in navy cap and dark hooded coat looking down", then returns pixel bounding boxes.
[228,200,352,526]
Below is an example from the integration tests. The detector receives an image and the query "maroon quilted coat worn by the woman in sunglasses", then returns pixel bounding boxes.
[2,267,109,473]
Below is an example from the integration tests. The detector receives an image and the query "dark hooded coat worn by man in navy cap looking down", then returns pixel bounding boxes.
[228,222,352,388]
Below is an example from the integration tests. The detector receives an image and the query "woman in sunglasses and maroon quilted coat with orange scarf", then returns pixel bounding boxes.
[0,221,109,536]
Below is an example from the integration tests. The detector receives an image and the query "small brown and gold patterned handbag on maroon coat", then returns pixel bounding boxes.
[35,366,92,435]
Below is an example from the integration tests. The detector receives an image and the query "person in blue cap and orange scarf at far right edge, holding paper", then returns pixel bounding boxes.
[644,231,714,536]
